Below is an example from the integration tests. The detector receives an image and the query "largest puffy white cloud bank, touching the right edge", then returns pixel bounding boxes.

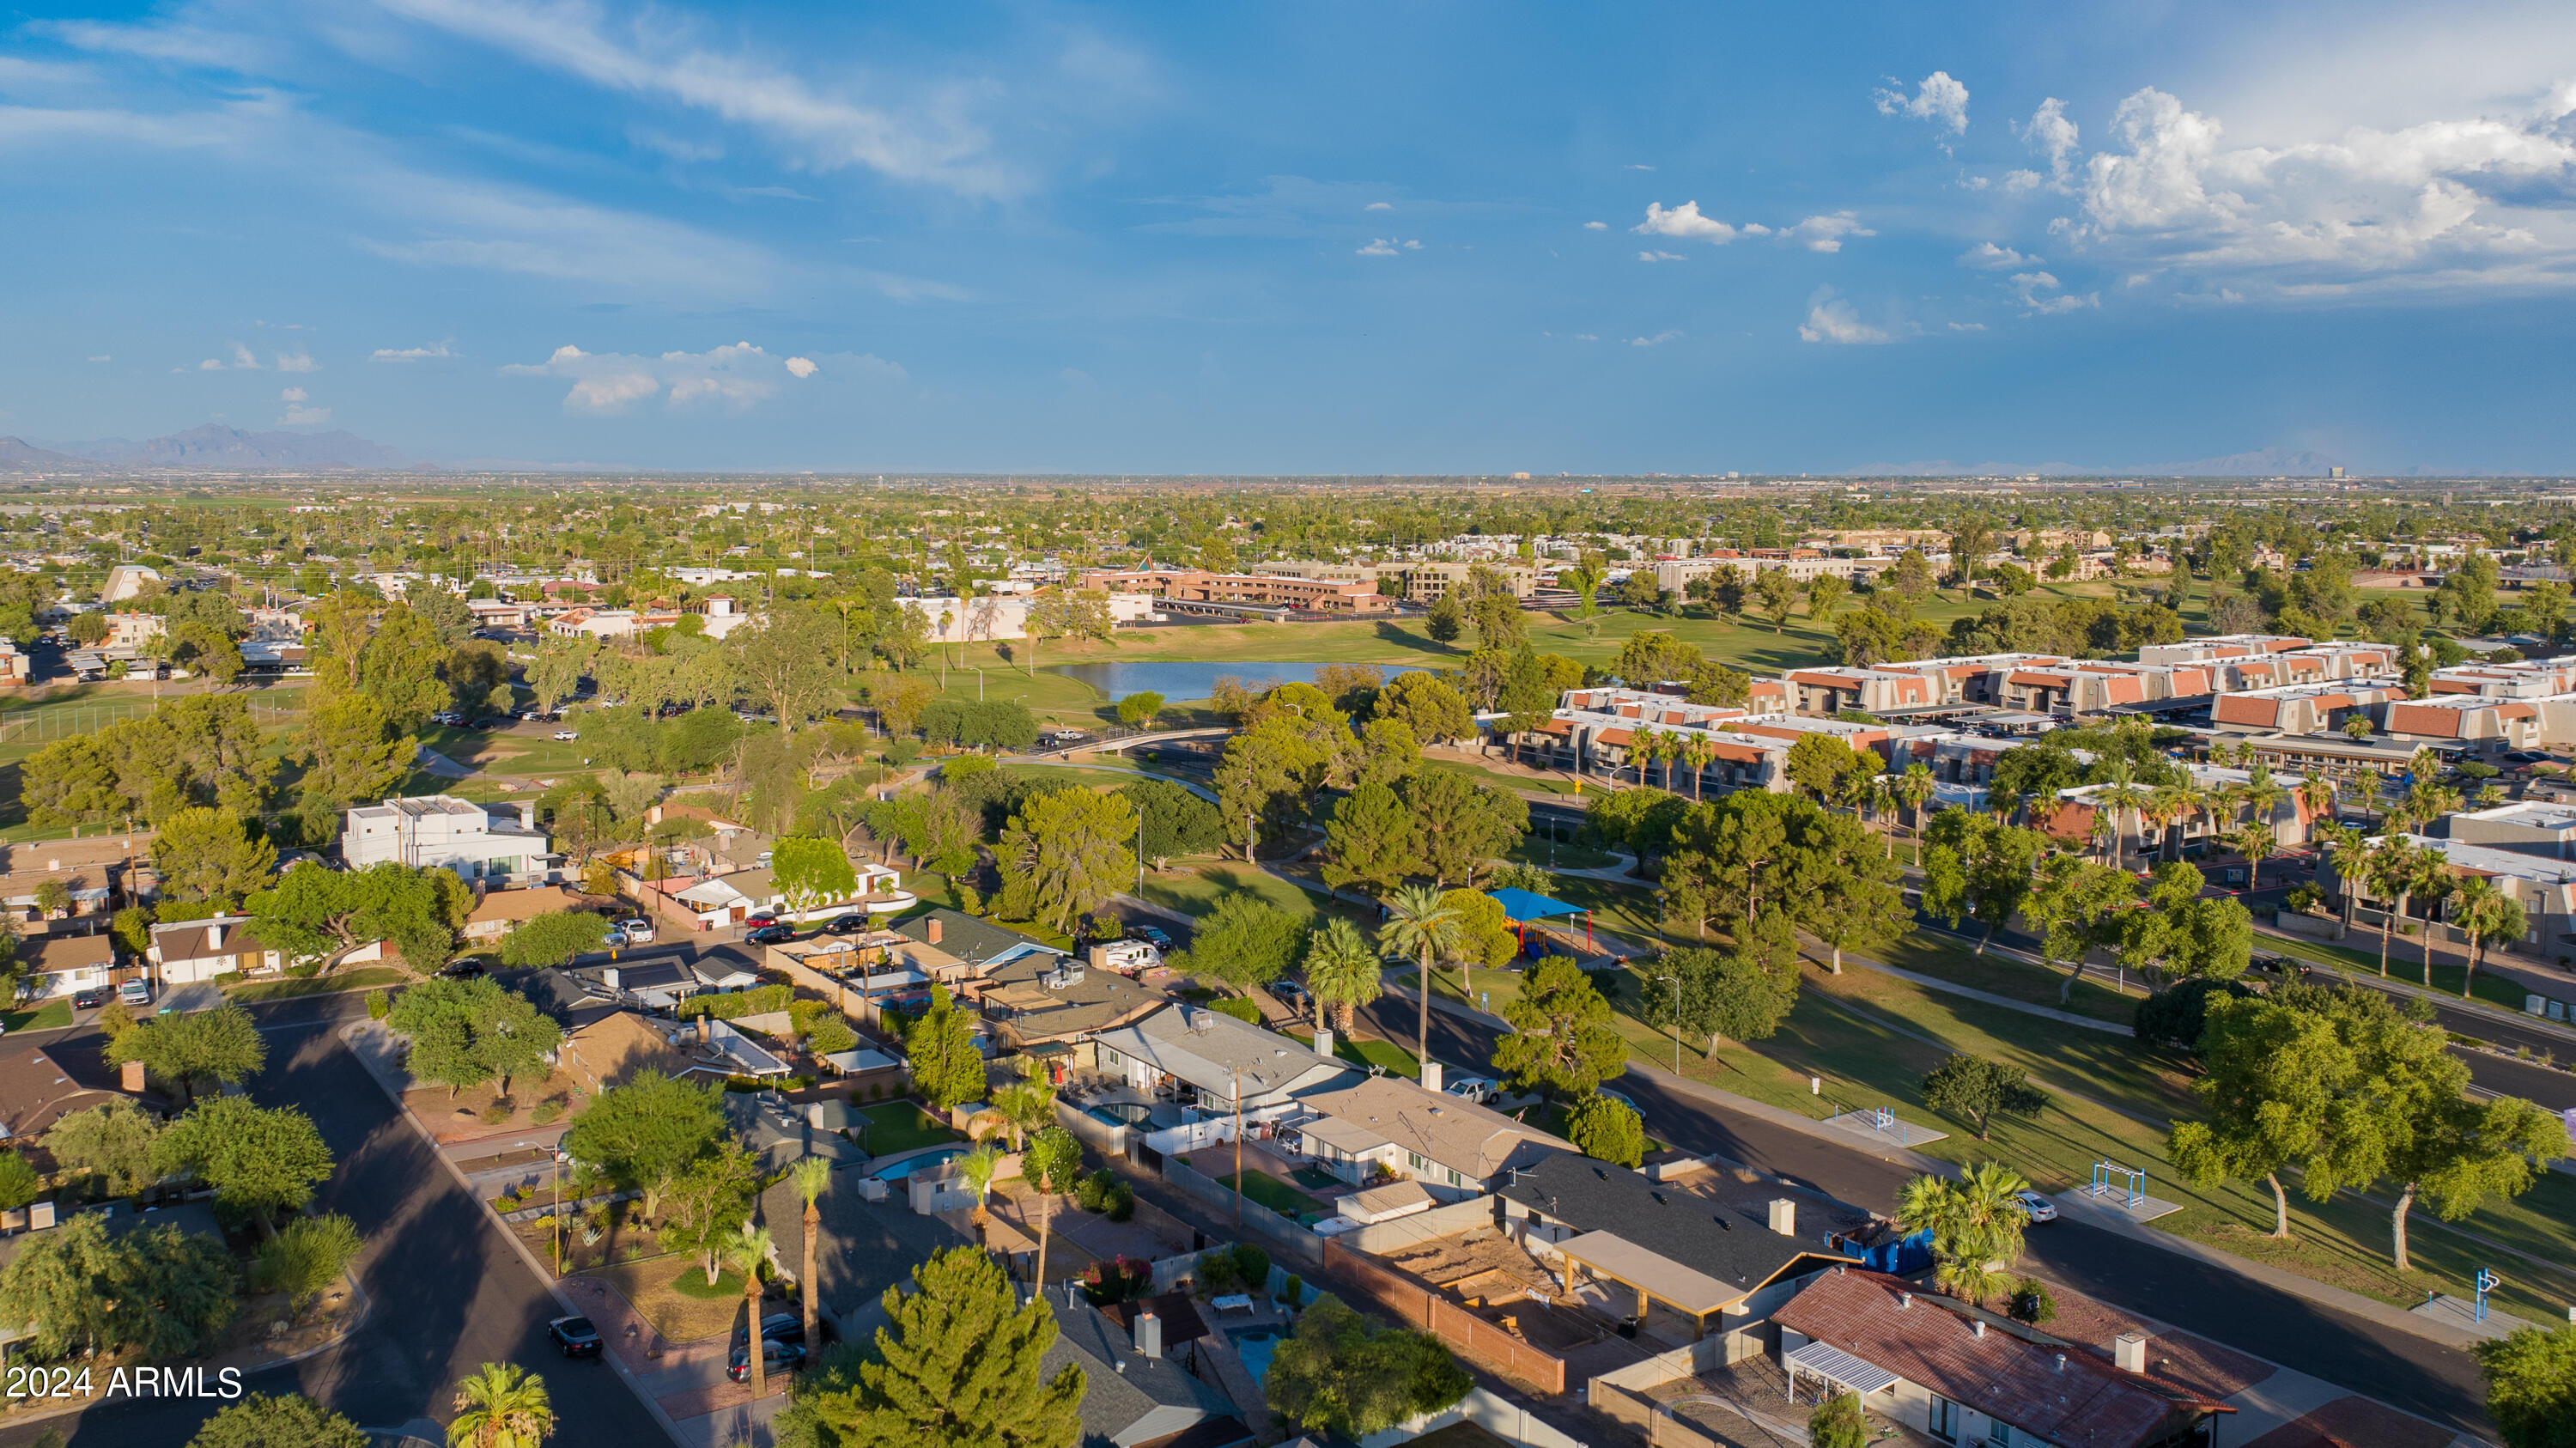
[2066,82,2576,296]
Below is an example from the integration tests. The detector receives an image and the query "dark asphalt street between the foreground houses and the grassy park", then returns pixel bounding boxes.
[1363,1000,2494,1438]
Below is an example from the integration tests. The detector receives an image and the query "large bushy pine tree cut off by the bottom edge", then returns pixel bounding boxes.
[778,1247,1084,1448]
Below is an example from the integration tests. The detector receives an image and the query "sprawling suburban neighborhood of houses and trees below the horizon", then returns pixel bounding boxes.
[0,477,2576,1448]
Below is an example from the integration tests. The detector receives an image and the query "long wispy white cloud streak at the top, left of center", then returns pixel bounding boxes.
[381,0,1018,196]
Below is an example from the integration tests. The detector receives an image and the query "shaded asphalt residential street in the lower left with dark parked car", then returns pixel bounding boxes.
[0,997,667,1448]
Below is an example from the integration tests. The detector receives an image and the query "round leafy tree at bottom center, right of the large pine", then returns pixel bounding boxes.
[1262,1296,1476,1438]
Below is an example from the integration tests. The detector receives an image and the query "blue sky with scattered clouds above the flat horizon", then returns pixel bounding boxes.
[0,0,2576,474]
